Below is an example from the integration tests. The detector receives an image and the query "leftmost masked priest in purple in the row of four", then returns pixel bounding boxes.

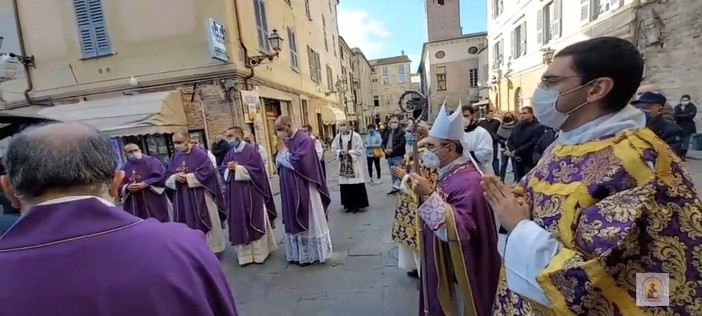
[119,144,173,222]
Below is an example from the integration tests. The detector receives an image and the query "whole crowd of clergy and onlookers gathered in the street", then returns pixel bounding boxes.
[0,37,702,316]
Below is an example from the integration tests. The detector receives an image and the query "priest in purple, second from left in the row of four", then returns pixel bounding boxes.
[165,131,227,253]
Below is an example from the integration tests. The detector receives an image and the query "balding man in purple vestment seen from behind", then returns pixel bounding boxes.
[0,123,237,316]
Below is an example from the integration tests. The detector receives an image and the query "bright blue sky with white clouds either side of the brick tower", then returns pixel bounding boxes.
[338,0,487,70]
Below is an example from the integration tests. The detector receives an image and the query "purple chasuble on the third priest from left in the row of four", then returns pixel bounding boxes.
[219,143,278,246]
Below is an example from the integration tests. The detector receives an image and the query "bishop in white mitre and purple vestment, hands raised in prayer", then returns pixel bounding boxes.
[410,103,501,316]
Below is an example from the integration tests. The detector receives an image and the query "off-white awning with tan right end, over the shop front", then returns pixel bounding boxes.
[38,91,187,137]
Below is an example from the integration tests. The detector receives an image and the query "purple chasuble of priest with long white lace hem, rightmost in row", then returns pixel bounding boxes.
[278,130,331,234]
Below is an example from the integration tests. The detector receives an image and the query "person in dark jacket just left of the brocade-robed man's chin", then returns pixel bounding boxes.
[505,106,545,181]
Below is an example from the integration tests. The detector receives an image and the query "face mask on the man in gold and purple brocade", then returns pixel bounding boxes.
[532,85,588,129]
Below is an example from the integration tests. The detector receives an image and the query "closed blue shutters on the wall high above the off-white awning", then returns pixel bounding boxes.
[73,0,113,58]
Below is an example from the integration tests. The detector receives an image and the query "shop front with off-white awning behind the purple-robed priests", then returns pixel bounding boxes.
[38,91,188,165]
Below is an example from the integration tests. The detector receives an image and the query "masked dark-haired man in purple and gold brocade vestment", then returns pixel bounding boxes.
[483,37,702,315]
